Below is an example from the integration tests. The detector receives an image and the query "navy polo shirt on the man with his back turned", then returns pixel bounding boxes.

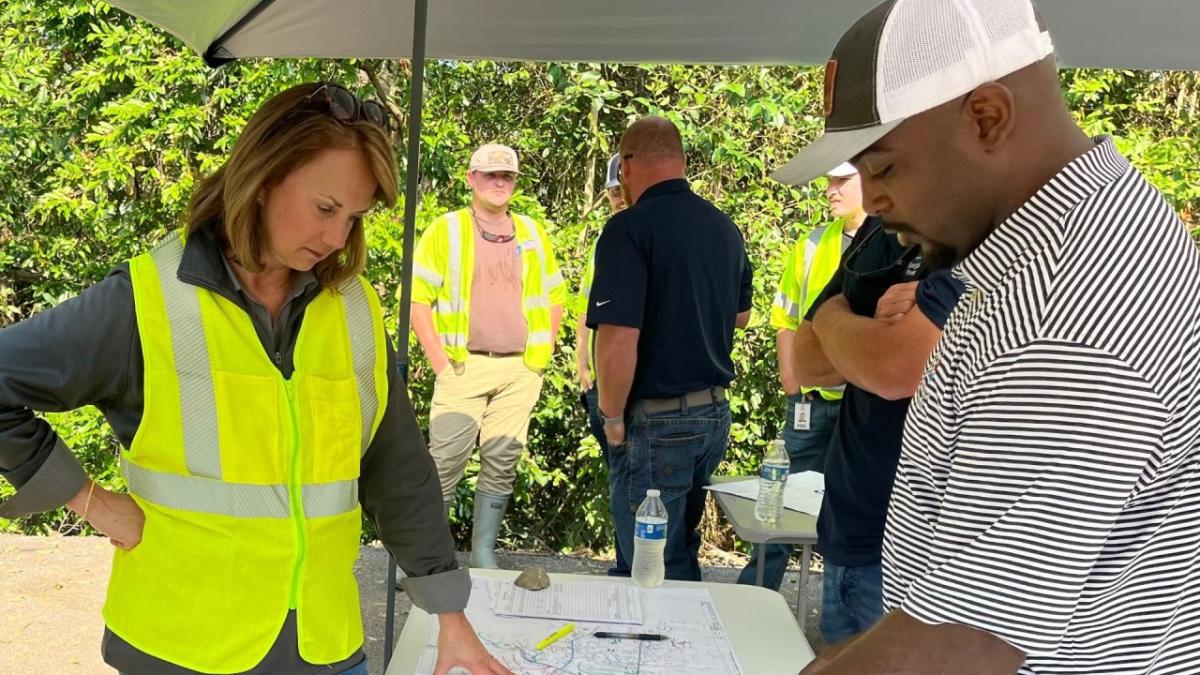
[588,179,752,401]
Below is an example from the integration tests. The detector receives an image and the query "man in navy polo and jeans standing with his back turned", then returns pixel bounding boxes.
[588,117,751,581]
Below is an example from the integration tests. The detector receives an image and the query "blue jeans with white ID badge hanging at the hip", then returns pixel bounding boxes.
[738,393,841,590]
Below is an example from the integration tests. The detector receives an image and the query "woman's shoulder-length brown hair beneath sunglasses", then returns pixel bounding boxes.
[187,83,396,288]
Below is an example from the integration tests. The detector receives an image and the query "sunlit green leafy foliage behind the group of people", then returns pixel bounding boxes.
[0,0,1200,551]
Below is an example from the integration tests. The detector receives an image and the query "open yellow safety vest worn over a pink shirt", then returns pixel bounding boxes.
[413,209,566,371]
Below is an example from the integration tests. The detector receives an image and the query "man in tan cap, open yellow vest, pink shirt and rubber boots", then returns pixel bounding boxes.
[413,144,566,568]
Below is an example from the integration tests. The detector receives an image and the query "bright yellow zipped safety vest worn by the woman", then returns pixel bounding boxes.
[103,230,388,673]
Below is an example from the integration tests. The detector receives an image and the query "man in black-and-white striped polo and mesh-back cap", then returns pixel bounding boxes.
[784,0,1200,674]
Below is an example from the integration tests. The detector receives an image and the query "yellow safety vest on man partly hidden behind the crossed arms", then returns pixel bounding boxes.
[770,219,846,401]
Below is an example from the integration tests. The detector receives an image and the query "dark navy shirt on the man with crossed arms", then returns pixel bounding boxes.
[806,219,964,567]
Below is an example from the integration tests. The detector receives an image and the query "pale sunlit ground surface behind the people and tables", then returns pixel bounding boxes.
[0,534,821,675]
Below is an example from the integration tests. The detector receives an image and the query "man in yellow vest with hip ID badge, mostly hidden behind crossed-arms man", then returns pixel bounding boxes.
[738,163,866,589]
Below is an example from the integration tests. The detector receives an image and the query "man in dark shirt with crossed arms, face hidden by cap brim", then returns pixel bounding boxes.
[797,217,962,644]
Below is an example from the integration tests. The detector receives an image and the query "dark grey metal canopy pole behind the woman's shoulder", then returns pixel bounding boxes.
[383,0,429,668]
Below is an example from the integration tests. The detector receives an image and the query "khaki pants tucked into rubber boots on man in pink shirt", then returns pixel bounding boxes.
[430,354,541,501]
